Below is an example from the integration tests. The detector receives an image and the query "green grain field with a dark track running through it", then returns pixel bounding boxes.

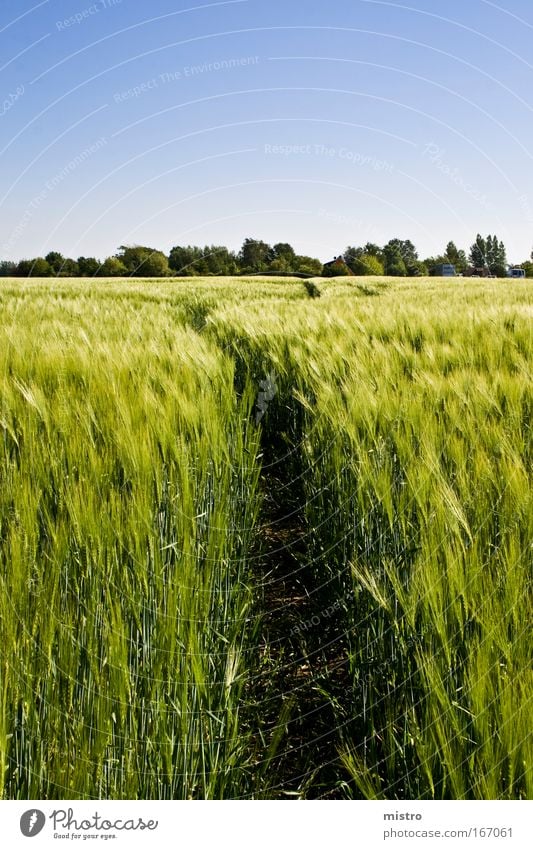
[0,278,533,799]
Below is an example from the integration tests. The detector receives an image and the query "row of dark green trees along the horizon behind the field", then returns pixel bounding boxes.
[0,234,533,277]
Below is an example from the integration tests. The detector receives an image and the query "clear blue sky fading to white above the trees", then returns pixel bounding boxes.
[0,0,533,262]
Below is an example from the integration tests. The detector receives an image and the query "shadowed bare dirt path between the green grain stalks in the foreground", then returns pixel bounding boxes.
[249,469,347,798]
